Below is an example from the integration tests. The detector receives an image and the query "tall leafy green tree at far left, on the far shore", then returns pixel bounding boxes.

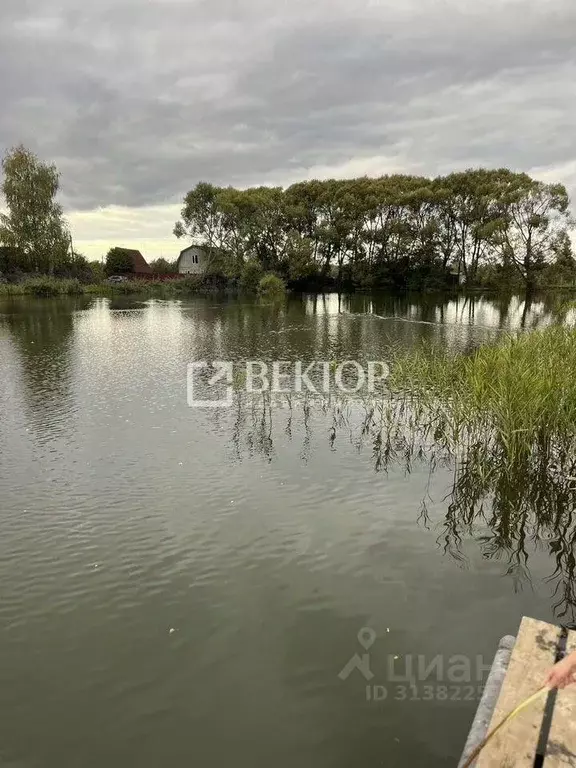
[0,146,72,274]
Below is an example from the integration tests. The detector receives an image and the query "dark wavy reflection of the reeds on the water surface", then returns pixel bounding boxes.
[231,392,576,624]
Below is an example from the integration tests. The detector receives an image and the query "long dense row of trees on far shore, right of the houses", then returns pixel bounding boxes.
[174,169,576,290]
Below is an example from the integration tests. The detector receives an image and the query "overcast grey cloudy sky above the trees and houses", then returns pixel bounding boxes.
[0,0,576,259]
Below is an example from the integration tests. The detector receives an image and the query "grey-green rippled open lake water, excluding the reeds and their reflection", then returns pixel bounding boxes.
[0,295,562,768]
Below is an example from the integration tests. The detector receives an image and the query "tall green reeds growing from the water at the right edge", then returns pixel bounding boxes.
[389,326,576,468]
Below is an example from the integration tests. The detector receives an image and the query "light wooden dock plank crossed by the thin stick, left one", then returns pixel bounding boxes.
[476,616,560,768]
